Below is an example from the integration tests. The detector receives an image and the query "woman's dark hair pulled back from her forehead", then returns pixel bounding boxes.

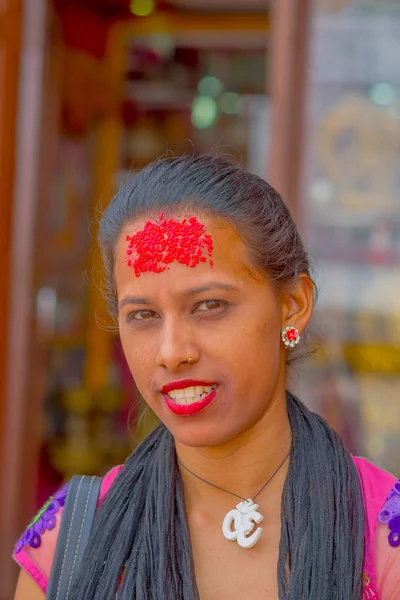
[99,156,316,314]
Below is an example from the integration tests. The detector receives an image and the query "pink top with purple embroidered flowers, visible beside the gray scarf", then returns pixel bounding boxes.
[13,458,400,600]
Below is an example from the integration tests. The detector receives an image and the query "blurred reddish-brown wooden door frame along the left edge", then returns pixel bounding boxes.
[0,0,48,600]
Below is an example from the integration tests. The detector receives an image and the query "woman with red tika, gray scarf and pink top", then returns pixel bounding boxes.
[14,156,400,600]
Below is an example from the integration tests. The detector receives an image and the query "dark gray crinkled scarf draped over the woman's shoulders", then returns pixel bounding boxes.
[71,393,365,600]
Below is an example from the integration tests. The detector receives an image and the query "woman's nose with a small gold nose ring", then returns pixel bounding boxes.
[156,320,200,373]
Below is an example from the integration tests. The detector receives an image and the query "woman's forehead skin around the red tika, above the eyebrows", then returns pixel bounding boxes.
[115,213,260,297]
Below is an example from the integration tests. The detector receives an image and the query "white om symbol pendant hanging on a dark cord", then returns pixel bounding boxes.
[222,499,264,548]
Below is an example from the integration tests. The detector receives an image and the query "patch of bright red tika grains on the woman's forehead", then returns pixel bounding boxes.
[126,213,214,277]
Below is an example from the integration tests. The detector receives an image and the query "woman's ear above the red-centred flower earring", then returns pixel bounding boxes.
[281,273,314,334]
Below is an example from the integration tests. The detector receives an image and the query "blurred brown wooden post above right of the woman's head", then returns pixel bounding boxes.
[268,0,313,226]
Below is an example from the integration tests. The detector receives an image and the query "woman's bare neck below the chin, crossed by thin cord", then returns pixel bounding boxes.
[175,396,291,507]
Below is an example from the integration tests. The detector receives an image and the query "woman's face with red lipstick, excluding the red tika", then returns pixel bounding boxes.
[115,216,306,447]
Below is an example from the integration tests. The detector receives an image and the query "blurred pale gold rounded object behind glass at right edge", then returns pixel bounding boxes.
[317,94,400,212]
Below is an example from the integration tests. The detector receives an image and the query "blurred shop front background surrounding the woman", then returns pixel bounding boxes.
[0,0,400,600]
